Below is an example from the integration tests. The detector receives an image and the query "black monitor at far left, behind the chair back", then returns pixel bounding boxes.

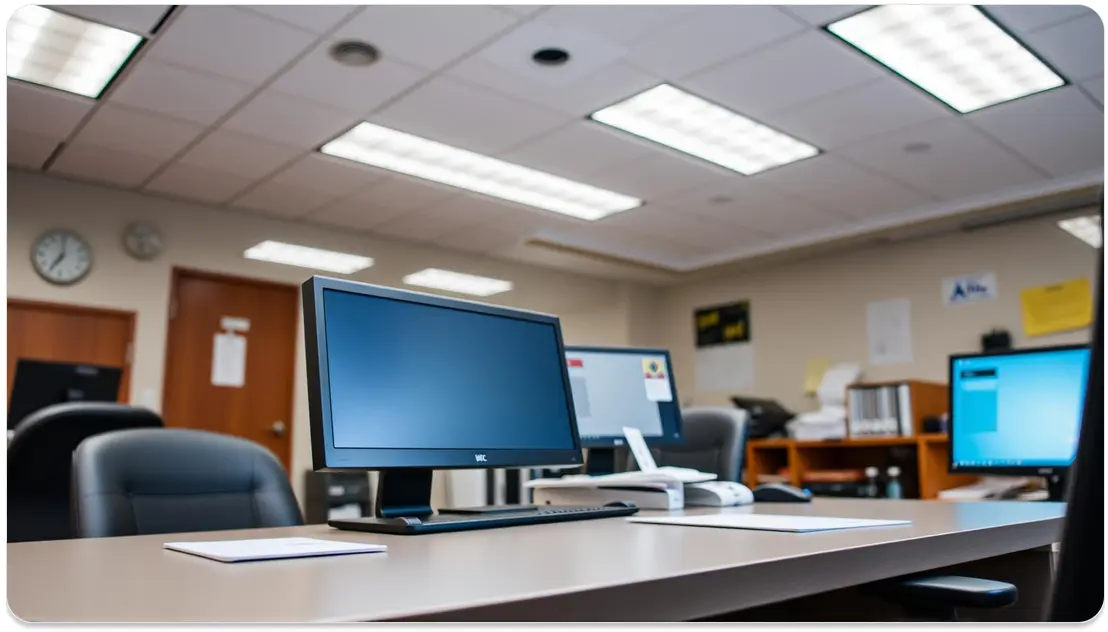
[8,358,123,430]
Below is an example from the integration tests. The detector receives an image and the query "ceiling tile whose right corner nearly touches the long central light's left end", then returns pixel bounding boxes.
[181,130,301,179]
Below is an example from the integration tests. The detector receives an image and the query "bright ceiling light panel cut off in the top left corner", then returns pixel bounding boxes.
[8,4,142,99]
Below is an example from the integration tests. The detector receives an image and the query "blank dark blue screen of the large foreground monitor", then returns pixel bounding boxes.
[322,289,575,450]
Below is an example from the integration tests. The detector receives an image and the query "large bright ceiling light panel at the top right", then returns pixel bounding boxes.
[828,4,1066,114]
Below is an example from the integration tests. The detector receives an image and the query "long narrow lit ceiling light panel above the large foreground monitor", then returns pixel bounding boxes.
[319,123,643,221]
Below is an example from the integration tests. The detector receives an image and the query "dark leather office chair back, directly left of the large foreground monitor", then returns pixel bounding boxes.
[73,429,304,538]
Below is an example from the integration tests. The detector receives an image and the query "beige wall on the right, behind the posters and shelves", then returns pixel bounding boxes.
[657,210,1096,410]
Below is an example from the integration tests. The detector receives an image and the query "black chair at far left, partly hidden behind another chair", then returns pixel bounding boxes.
[8,401,162,542]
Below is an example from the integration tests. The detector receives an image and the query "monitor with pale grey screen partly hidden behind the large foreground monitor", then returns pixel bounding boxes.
[565,347,684,475]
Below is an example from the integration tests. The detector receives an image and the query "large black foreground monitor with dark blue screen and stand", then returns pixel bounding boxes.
[302,276,582,517]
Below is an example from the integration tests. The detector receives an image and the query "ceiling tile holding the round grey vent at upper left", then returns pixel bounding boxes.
[269,40,427,116]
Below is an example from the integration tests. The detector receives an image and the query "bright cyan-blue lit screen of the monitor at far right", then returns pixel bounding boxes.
[951,348,1089,468]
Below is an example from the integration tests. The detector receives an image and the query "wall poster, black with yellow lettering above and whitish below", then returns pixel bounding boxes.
[693,300,755,394]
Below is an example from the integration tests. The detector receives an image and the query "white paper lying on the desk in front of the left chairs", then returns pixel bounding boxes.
[165,538,388,562]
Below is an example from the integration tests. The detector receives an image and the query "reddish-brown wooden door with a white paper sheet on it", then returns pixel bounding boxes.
[162,269,299,470]
